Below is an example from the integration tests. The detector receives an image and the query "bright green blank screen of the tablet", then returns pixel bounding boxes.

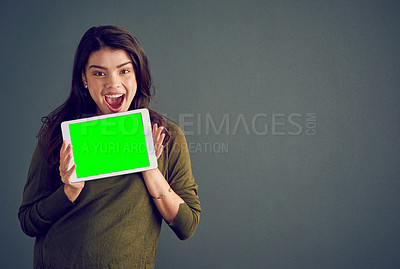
[69,113,149,178]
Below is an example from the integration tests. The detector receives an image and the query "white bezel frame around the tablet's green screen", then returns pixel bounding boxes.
[61,108,158,182]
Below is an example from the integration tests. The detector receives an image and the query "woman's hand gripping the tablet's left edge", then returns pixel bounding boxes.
[59,141,85,202]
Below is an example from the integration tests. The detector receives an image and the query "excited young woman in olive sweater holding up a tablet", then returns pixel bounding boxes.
[18,26,201,268]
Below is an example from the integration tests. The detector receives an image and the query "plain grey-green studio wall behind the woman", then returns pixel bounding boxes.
[0,0,400,269]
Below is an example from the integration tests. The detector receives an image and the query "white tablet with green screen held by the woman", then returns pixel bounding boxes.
[61,108,157,182]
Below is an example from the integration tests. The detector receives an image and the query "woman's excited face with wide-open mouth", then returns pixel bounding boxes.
[82,48,137,115]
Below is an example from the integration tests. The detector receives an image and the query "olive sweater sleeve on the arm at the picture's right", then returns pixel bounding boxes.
[166,124,201,240]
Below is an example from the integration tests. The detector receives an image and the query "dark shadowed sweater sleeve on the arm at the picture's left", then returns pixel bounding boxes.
[18,145,74,236]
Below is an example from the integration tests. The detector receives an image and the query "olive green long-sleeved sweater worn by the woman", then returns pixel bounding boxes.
[18,123,201,269]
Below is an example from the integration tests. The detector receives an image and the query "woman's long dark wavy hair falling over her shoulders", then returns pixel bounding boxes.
[38,25,170,173]
